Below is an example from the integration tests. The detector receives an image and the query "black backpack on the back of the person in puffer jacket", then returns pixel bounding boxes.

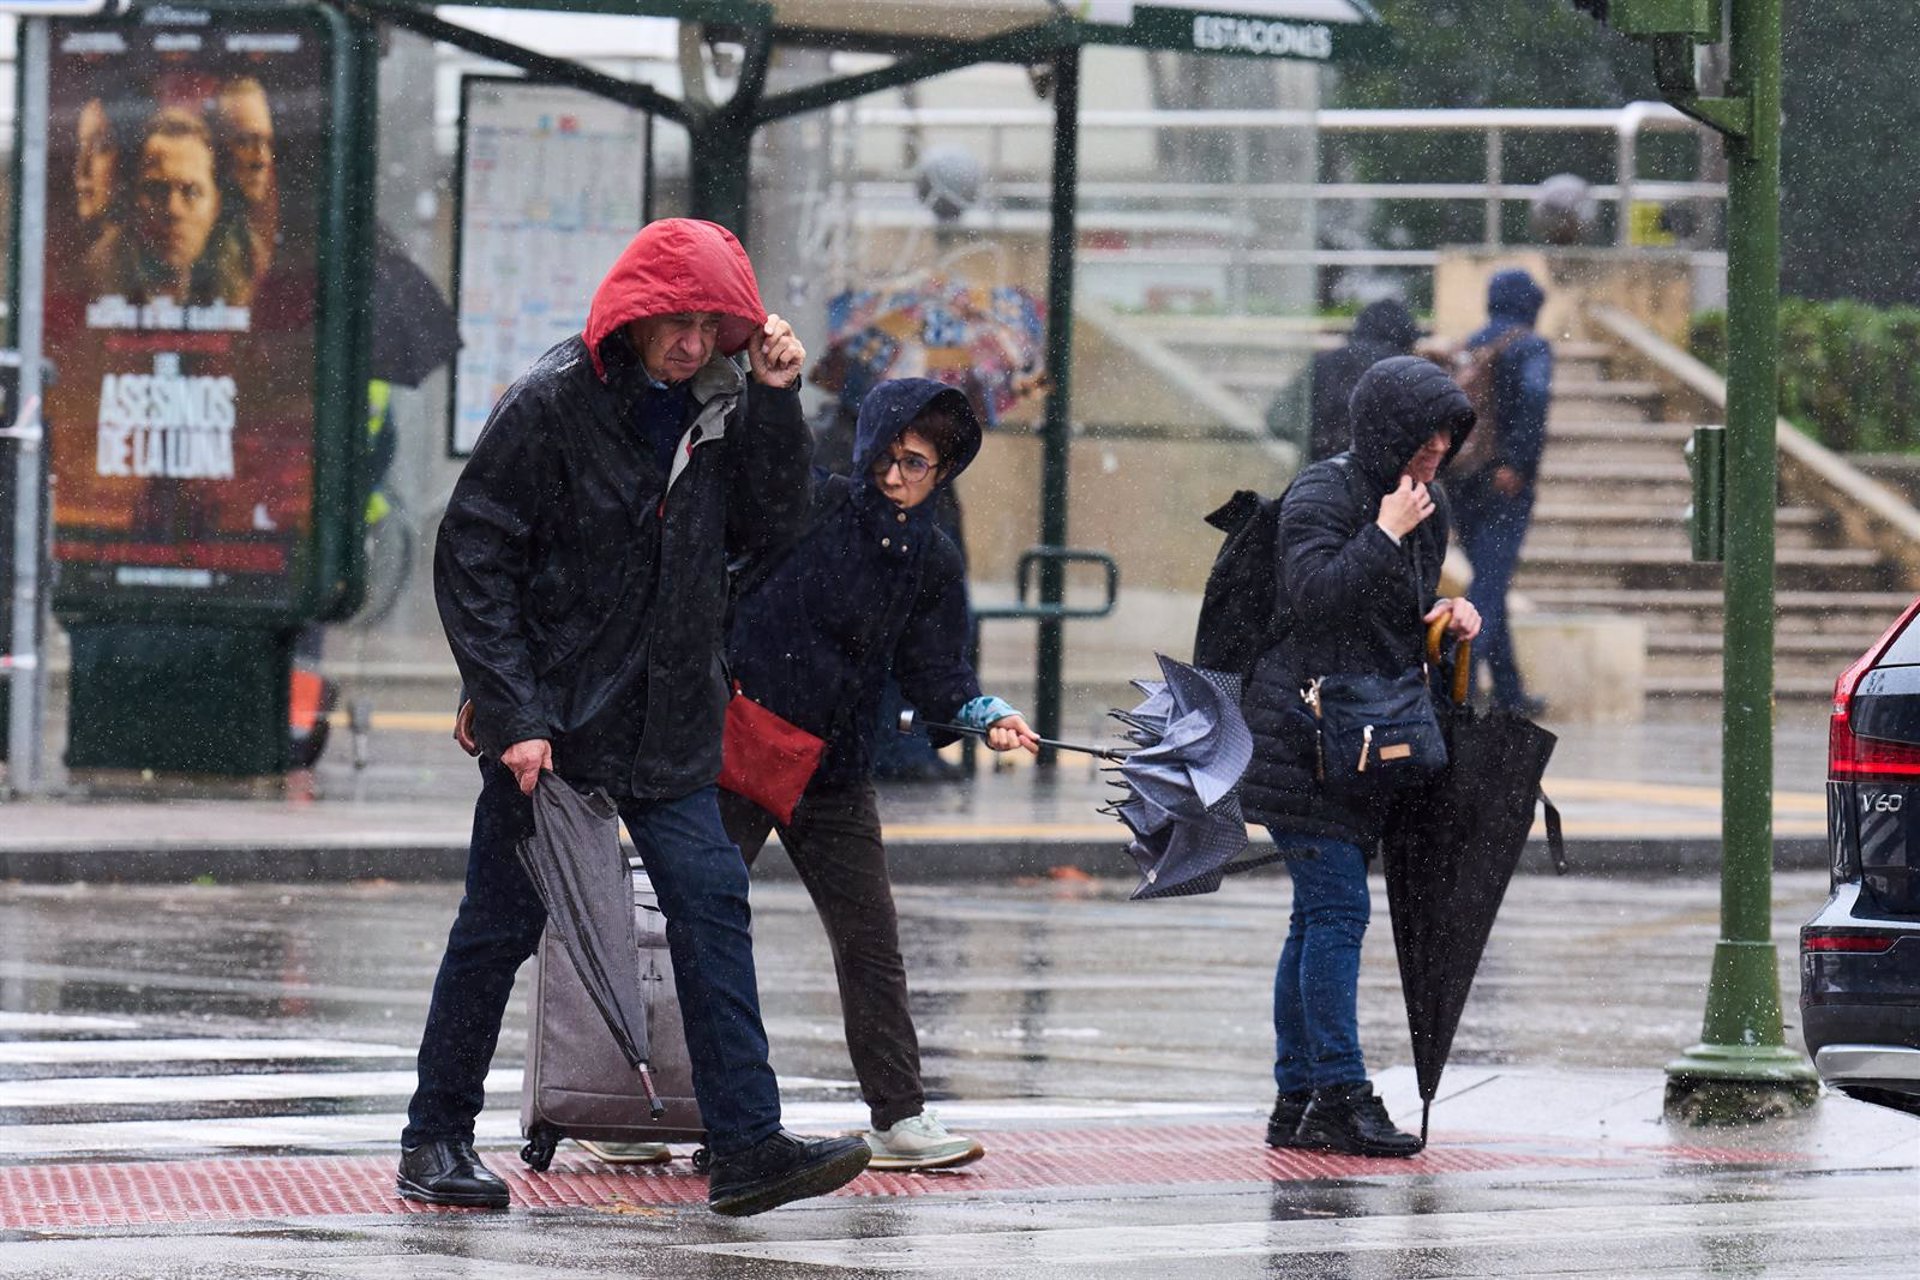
[1194,453,1354,677]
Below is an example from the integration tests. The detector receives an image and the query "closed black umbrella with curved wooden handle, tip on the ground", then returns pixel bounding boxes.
[1382,620,1565,1142]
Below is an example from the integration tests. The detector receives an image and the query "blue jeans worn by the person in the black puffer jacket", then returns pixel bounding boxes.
[1271,831,1373,1094]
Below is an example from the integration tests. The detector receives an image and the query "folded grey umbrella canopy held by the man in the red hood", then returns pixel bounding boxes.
[515,773,647,1071]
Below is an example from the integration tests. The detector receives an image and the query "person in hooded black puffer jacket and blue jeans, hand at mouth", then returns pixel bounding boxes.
[1240,355,1480,1155]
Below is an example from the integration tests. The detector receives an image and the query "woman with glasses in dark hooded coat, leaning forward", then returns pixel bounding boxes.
[720,378,1039,1169]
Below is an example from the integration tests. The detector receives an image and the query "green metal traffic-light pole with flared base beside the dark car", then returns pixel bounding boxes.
[1667,0,1818,1123]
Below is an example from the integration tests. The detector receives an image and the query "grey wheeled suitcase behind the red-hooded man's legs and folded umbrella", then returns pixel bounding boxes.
[520,860,707,1171]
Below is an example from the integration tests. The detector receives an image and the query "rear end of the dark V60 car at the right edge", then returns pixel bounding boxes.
[1801,601,1920,1115]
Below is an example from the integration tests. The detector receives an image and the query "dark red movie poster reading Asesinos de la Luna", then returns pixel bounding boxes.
[46,10,330,610]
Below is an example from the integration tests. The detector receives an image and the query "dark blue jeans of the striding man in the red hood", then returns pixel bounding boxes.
[399,762,780,1155]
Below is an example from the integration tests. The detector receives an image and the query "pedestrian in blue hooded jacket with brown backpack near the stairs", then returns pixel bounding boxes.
[1446,271,1553,716]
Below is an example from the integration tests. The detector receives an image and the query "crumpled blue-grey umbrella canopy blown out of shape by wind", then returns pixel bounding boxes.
[1108,654,1254,898]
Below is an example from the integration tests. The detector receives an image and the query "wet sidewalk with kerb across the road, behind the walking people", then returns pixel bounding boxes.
[0,712,1826,883]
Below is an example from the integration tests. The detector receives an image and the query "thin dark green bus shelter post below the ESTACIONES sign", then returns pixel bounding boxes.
[1033,44,1079,766]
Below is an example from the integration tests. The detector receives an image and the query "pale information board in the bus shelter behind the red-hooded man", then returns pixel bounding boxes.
[447,77,653,457]
